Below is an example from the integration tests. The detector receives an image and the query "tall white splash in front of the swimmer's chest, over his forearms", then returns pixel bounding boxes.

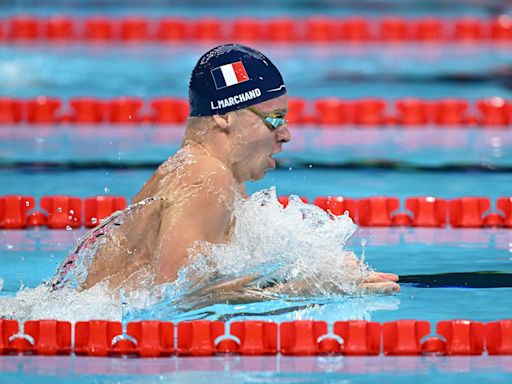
[167,188,369,304]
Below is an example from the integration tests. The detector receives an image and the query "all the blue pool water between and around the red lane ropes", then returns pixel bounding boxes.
[0,1,512,383]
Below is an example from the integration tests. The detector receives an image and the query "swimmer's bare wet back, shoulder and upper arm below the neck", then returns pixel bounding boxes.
[78,148,237,289]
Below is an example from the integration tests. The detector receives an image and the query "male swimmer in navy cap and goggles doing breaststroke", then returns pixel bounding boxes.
[52,44,400,293]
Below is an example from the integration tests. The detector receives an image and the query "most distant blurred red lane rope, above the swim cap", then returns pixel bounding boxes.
[0,15,512,43]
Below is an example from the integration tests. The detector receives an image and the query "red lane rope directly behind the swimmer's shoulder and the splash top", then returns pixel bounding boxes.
[0,195,512,229]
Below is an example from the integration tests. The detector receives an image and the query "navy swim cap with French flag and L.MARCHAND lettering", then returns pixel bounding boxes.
[188,44,286,116]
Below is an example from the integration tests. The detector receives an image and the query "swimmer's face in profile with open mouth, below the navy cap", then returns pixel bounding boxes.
[231,94,291,181]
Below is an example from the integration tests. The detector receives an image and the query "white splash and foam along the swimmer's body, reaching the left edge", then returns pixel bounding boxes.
[0,188,369,322]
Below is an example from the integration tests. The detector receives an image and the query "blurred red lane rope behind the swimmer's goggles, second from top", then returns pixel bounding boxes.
[0,96,512,125]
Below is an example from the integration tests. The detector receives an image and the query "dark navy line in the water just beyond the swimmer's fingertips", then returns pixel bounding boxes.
[400,271,512,288]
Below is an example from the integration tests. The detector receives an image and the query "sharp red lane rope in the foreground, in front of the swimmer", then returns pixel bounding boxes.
[0,319,512,357]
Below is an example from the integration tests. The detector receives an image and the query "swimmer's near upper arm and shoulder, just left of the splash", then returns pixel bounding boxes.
[154,164,236,284]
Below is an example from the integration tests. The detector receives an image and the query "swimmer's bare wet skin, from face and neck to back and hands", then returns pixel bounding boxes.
[84,94,400,293]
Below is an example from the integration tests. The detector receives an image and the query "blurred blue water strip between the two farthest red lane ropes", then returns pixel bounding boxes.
[0,43,512,99]
